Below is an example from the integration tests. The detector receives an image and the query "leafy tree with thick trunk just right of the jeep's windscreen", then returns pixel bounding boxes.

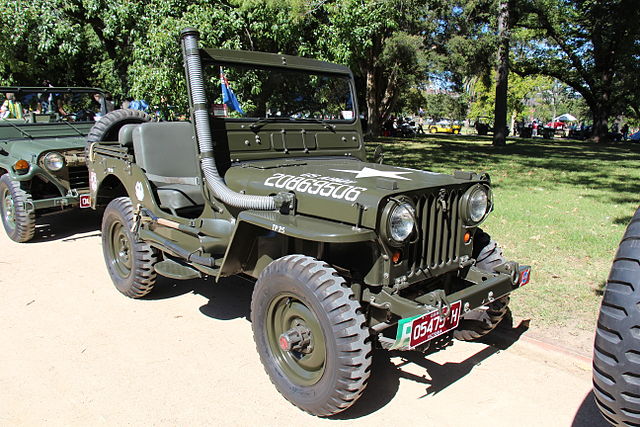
[314,0,435,136]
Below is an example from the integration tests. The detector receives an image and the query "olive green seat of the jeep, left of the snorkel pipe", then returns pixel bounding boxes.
[132,122,204,215]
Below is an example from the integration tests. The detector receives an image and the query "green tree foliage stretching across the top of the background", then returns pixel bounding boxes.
[0,0,640,139]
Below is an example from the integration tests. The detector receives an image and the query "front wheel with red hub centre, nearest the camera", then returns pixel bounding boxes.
[251,255,371,417]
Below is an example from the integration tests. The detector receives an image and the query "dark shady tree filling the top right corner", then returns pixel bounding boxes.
[513,0,640,142]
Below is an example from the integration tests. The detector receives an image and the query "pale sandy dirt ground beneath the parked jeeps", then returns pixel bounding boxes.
[0,212,606,426]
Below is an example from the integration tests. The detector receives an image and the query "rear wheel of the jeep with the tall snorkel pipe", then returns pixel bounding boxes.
[102,197,158,298]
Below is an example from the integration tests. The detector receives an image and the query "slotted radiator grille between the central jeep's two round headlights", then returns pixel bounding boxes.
[409,190,462,273]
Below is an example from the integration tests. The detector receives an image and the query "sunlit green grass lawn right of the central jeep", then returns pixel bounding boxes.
[368,135,640,345]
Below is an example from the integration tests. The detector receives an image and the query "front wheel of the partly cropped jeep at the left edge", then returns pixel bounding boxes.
[0,174,36,243]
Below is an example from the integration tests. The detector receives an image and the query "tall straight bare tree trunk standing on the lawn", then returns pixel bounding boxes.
[493,0,509,146]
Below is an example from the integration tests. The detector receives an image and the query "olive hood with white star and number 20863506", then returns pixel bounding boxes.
[225,158,478,228]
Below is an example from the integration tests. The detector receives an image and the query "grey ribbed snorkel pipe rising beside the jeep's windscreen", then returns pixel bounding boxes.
[181,28,280,210]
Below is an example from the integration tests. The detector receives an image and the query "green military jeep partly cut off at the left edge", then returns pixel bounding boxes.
[0,87,114,242]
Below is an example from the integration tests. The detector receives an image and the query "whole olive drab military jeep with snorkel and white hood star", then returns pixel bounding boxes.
[88,29,529,416]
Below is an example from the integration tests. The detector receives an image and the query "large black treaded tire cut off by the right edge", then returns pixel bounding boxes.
[593,209,640,426]
